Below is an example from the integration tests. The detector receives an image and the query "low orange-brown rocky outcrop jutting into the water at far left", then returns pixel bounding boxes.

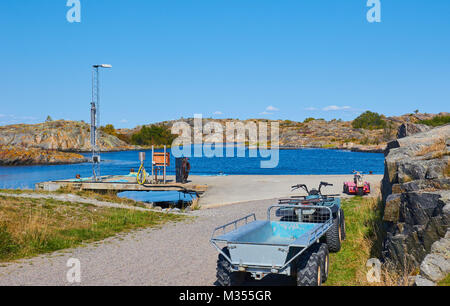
[0,146,87,166]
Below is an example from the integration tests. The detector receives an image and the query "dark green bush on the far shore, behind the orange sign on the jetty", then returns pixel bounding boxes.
[131,125,176,146]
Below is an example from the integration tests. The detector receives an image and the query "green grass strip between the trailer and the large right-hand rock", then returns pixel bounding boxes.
[325,197,382,286]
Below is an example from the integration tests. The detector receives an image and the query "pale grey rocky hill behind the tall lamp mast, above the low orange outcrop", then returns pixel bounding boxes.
[0,120,135,152]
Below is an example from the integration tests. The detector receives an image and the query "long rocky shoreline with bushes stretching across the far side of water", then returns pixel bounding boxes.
[0,111,450,166]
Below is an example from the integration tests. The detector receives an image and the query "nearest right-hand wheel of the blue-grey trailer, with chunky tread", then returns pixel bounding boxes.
[297,253,322,286]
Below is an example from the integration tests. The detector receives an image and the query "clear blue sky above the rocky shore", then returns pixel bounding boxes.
[0,0,450,127]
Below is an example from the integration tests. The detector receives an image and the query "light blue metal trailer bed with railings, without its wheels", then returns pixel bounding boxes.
[211,205,333,280]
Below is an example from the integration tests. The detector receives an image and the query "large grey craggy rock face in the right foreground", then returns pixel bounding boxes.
[382,125,450,267]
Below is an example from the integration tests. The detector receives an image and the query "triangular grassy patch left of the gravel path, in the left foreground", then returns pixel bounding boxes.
[0,196,187,261]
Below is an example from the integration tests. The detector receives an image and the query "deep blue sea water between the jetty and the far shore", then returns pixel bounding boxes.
[0,149,384,201]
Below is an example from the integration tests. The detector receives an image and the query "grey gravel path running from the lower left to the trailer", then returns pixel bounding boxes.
[0,200,276,286]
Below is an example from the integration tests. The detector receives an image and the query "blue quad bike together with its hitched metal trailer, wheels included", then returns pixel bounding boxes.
[211,185,345,286]
